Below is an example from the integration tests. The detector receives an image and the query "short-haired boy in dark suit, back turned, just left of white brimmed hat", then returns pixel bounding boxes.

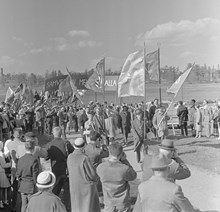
[16,140,39,212]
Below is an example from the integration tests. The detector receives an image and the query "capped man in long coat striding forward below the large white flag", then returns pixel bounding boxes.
[132,109,148,163]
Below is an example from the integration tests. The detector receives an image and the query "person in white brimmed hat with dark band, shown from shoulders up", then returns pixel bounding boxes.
[26,171,66,212]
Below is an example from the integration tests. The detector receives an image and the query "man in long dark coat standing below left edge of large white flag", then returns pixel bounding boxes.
[120,105,131,145]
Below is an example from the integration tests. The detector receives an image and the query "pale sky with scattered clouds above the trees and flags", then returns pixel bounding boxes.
[0,0,220,74]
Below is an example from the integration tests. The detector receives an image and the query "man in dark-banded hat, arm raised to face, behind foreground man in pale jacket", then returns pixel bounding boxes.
[143,139,191,182]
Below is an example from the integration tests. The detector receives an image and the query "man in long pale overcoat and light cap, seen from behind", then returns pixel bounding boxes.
[67,138,100,212]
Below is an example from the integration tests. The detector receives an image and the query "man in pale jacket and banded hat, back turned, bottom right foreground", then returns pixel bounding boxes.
[133,155,199,212]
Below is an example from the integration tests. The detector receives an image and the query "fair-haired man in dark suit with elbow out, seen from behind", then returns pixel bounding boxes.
[46,127,74,209]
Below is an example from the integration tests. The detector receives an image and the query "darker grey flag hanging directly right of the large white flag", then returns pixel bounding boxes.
[145,50,159,81]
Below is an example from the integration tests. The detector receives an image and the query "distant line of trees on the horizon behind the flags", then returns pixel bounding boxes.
[4,63,220,87]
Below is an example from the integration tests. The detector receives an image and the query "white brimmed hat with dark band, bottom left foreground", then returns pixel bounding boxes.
[36,171,56,188]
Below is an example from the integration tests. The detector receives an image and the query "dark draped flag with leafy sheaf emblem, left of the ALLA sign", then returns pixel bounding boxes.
[85,58,105,92]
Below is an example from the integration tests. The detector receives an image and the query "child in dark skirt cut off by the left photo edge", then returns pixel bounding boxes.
[0,141,11,208]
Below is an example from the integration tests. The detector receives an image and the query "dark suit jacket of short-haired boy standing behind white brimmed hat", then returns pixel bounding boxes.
[16,153,39,194]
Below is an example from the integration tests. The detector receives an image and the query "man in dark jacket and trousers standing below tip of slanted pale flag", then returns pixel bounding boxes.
[177,101,188,136]
